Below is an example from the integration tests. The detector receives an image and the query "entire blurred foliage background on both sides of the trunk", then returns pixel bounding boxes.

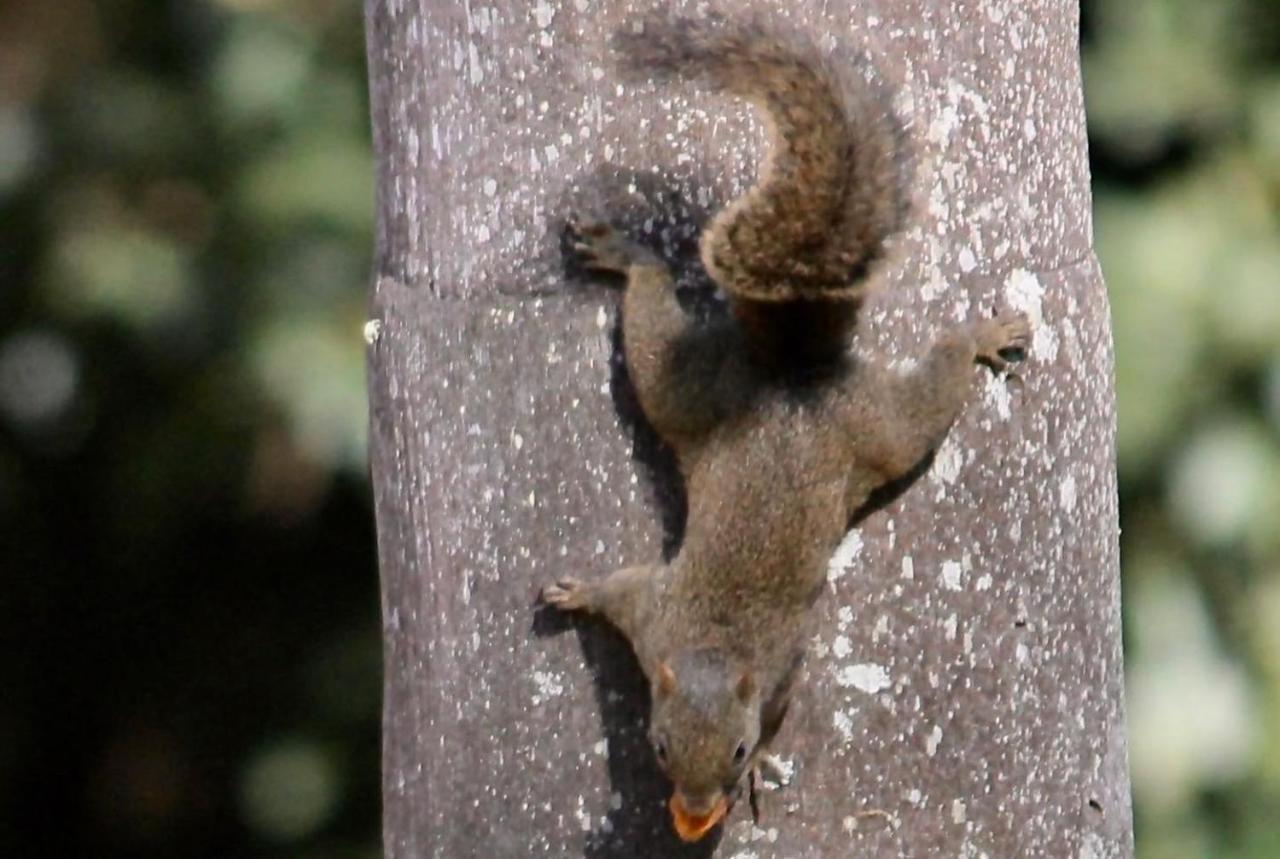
[0,0,1280,859]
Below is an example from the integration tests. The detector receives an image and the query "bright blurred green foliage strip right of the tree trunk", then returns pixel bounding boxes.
[1084,0,1280,859]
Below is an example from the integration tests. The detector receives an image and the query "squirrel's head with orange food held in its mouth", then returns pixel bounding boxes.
[649,649,760,841]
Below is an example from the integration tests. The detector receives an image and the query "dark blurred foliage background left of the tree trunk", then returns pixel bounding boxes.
[0,0,381,859]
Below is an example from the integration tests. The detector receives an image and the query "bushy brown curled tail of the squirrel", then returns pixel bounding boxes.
[613,17,906,305]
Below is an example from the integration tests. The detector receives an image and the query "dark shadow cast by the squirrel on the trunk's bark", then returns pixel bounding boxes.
[532,169,727,859]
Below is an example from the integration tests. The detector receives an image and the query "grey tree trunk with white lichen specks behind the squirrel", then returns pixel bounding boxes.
[366,0,1132,859]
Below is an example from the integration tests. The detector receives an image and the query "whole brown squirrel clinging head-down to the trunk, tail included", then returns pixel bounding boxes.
[541,11,1030,841]
